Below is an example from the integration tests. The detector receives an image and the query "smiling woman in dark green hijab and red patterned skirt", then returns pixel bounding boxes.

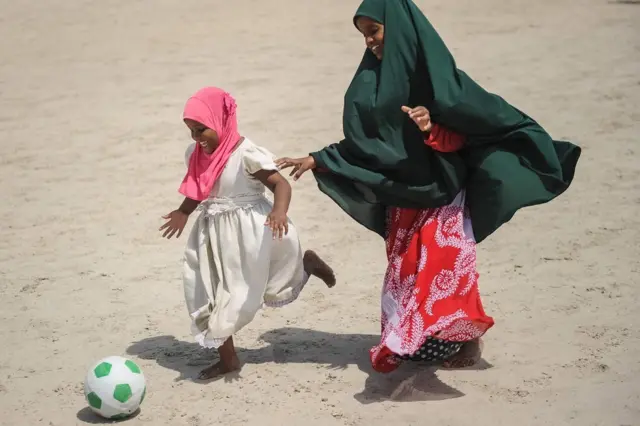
[277,0,580,372]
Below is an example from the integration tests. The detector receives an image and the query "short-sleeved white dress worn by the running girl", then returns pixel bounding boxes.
[183,139,309,348]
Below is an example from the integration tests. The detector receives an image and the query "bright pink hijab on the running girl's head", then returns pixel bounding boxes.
[180,87,240,201]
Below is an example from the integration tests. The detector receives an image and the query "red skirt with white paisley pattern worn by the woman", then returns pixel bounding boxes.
[370,192,493,373]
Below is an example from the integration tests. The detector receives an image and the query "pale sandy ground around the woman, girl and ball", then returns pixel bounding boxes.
[0,0,640,426]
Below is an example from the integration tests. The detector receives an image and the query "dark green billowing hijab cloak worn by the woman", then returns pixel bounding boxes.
[311,0,580,242]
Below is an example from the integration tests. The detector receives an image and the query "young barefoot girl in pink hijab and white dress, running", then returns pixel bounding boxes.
[160,87,335,380]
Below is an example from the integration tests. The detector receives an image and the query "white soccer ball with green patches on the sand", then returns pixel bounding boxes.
[84,356,147,420]
